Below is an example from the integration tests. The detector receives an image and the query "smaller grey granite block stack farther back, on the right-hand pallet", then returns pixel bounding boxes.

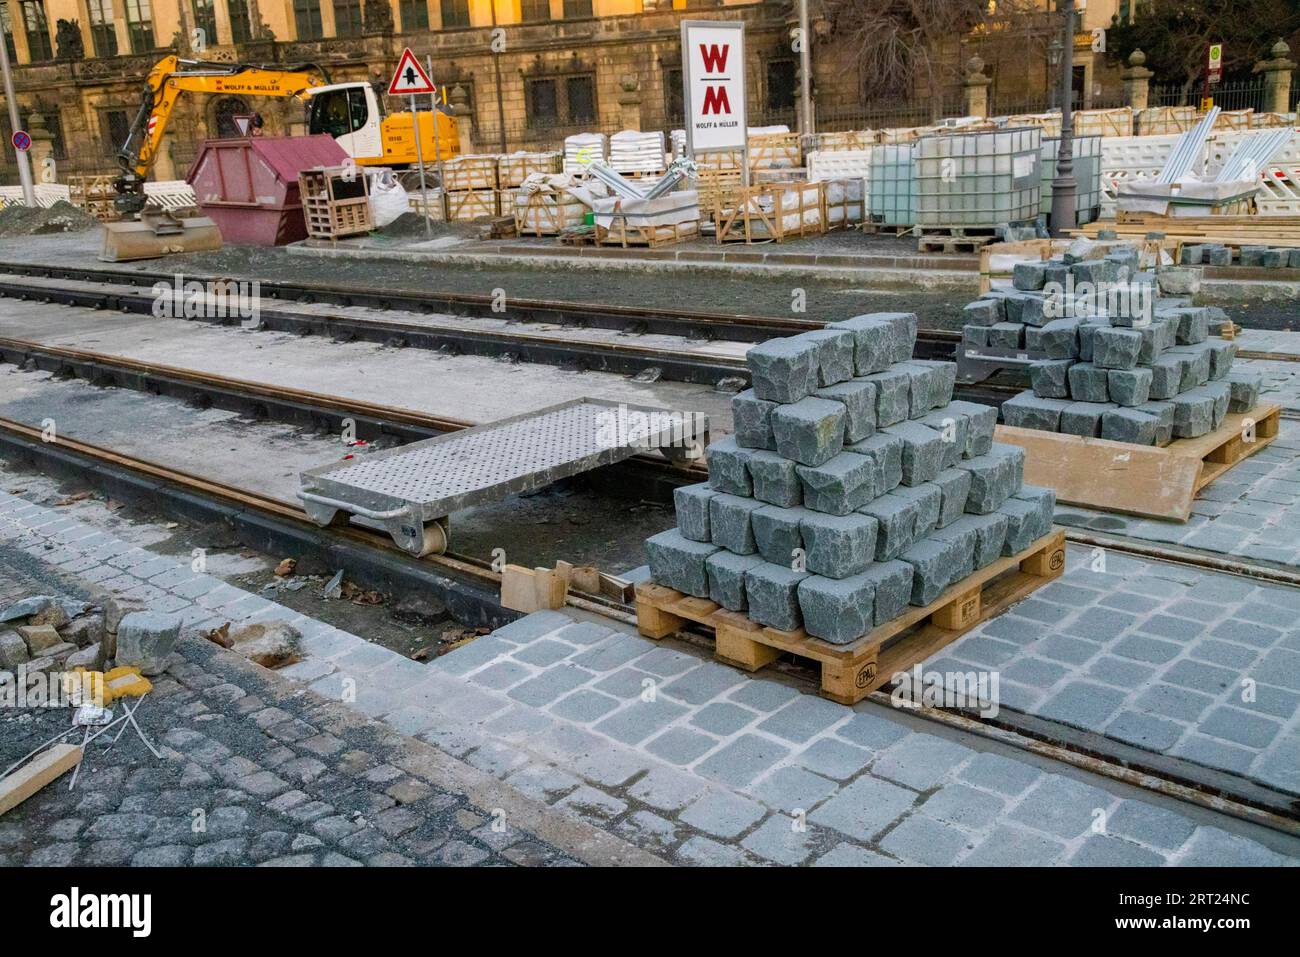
[962,246,1262,446]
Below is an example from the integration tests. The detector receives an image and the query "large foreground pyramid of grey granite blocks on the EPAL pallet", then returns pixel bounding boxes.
[646,313,1056,645]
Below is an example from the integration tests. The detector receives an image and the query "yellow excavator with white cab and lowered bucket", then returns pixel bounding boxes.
[100,56,460,263]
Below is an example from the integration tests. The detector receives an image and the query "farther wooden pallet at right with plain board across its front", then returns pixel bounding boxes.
[995,403,1282,521]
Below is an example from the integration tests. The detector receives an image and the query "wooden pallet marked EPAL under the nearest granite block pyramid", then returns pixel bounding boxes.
[637,531,1065,705]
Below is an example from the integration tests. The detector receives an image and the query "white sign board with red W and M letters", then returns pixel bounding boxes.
[681,20,748,155]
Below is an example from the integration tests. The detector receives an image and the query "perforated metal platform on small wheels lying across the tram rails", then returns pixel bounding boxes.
[298,399,709,554]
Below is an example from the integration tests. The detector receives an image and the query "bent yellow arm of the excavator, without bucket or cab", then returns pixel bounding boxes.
[116,56,329,218]
